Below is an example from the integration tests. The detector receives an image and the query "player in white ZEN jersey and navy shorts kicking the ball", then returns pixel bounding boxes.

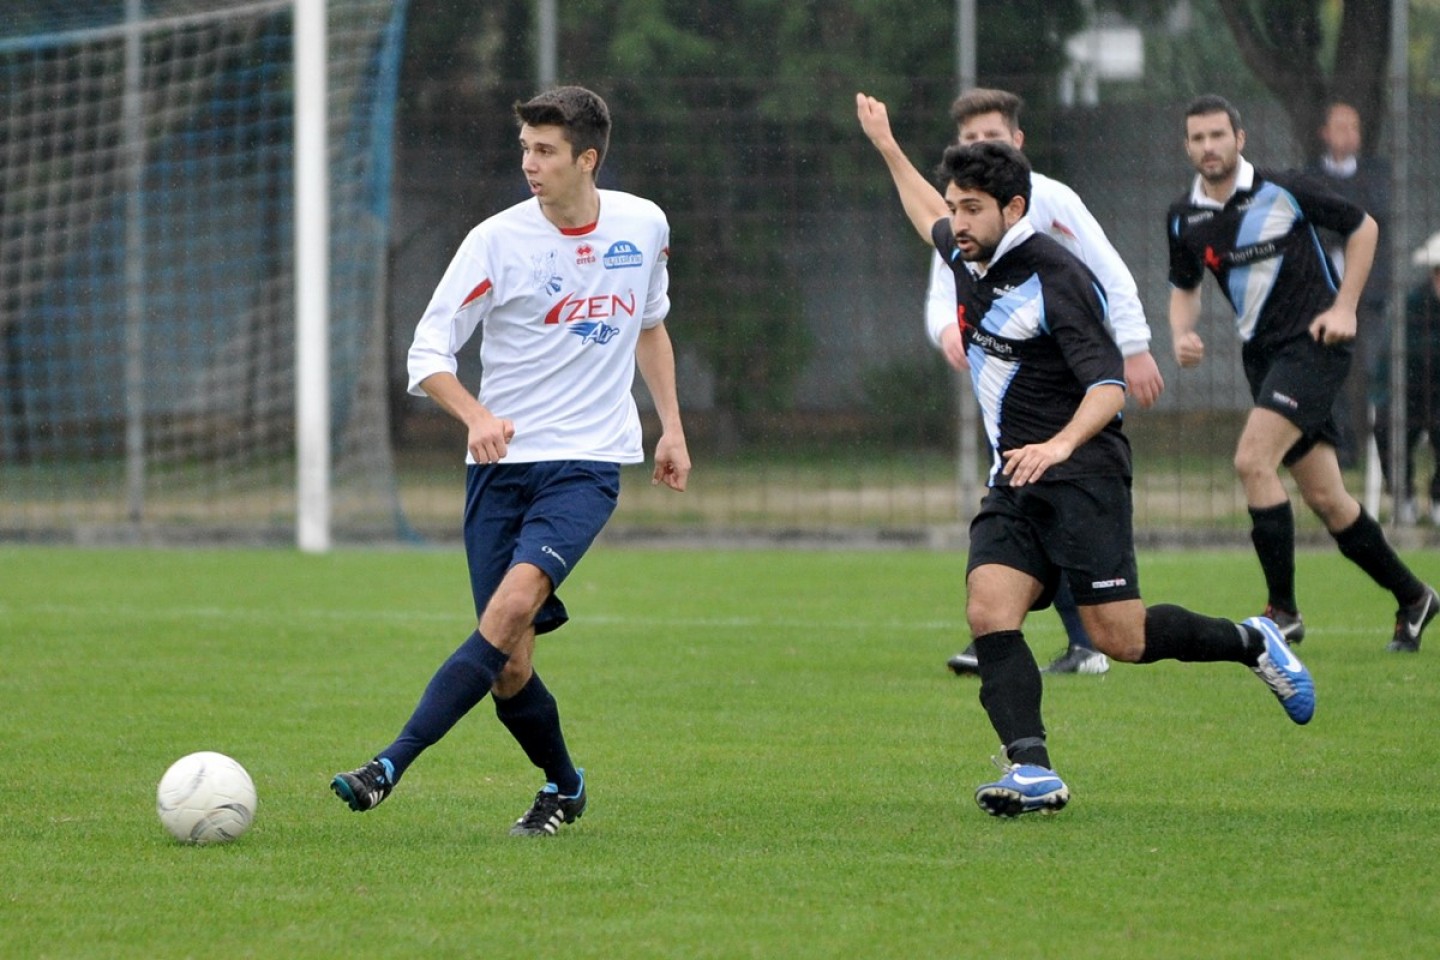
[331,86,690,836]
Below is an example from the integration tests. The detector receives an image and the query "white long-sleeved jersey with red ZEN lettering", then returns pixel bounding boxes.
[408,190,670,463]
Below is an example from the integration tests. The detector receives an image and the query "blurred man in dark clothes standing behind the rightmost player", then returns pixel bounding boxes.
[1309,101,1390,468]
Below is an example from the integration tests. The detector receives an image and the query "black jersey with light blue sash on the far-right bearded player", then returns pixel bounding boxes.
[1166,161,1365,350]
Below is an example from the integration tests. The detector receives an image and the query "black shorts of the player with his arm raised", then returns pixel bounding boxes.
[965,476,1140,610]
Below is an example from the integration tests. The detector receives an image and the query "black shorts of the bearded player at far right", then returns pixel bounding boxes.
[1243,337,1354,466]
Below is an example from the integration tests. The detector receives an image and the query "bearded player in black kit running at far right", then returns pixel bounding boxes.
[1166,94,1440,652]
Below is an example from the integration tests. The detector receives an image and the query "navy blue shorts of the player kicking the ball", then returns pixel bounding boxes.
[465,461,621,633]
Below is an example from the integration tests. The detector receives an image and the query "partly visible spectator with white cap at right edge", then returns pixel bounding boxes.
[1375,233,1440,527]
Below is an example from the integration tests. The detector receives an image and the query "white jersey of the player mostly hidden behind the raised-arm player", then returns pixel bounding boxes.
[924,173,1151,357]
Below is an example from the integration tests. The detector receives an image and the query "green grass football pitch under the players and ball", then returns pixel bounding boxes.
[0,547,1440,960]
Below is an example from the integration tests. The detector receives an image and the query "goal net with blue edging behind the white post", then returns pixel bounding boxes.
[0,0,405,543]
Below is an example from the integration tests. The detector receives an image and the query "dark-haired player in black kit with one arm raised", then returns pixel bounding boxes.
[855,94,1315,816]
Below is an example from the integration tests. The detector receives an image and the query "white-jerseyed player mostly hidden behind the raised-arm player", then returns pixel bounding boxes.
[924,86,1165,675]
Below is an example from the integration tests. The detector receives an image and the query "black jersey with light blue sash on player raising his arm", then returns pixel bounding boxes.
[930,219,1130,486]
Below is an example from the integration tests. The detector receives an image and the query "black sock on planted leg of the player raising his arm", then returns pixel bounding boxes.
[975,630,1050,767]
